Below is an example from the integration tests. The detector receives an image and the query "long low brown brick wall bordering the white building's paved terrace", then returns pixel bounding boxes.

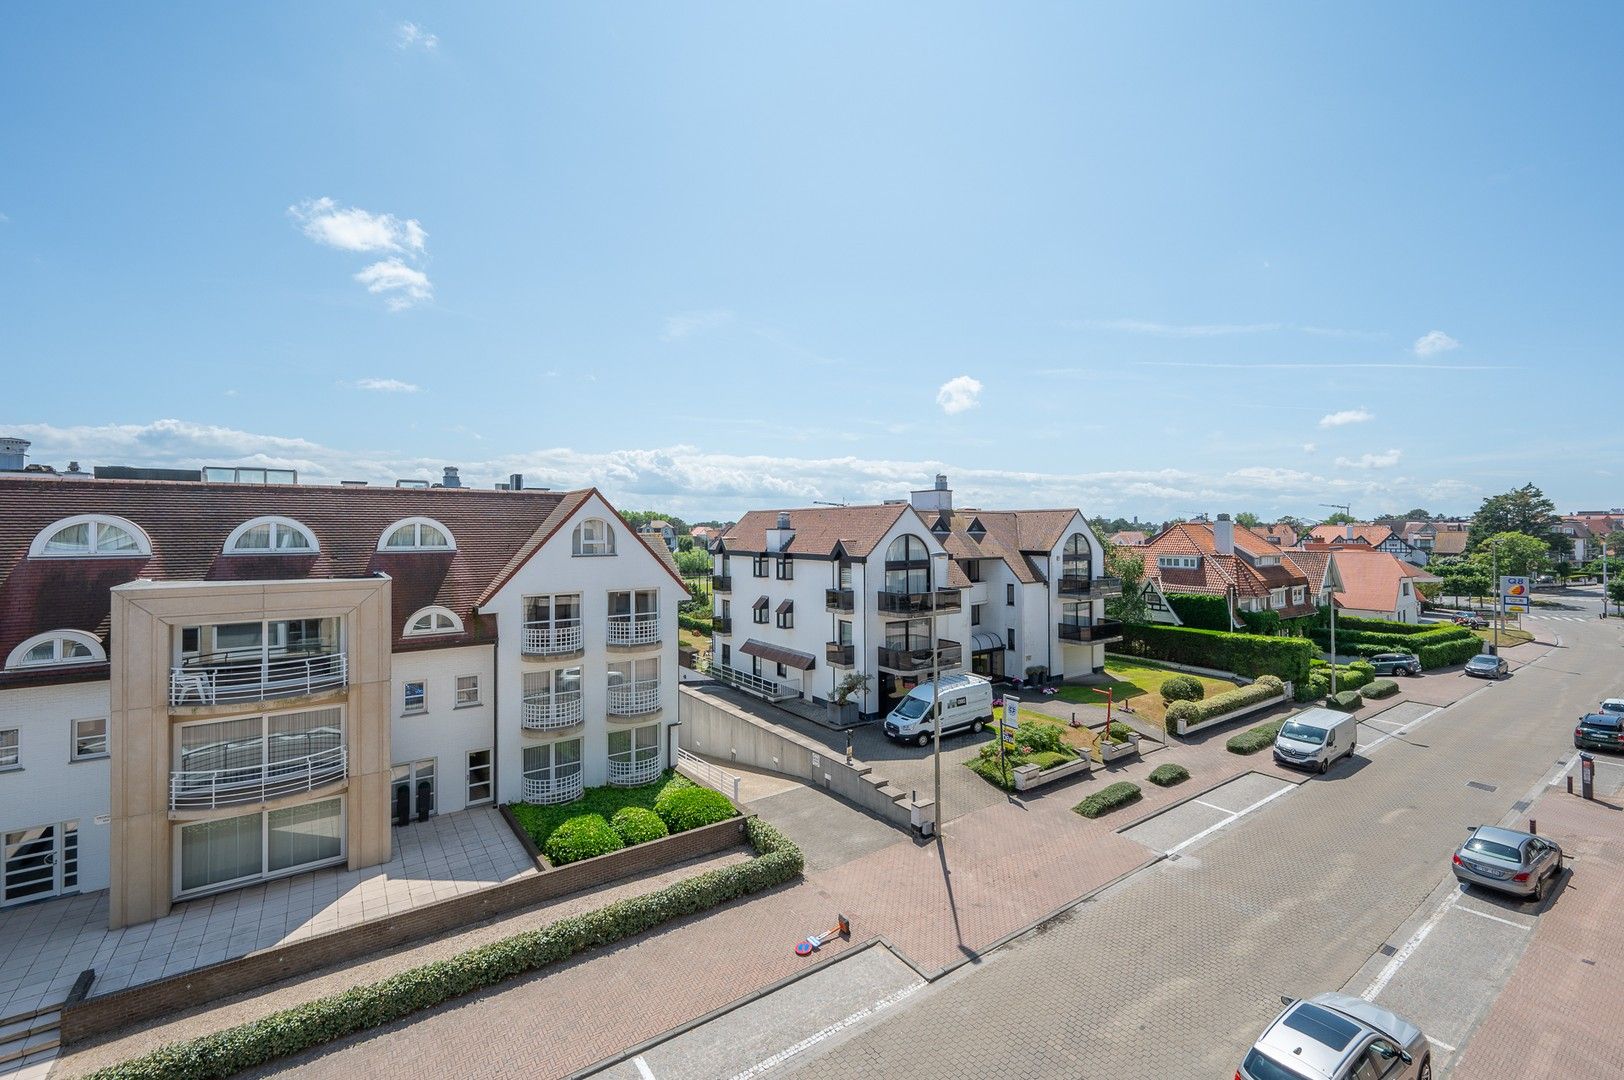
[62,817,745,1044]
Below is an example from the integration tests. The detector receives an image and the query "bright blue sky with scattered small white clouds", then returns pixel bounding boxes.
[0,2,1624,520]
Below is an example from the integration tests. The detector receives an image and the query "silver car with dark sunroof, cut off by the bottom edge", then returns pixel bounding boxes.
[1234,994,1432,1080]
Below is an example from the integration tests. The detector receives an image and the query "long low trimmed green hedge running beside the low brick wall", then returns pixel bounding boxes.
[91,819,804,1080]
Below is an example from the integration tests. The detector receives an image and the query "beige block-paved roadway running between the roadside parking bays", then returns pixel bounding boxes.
[781,619,1624,1080]
